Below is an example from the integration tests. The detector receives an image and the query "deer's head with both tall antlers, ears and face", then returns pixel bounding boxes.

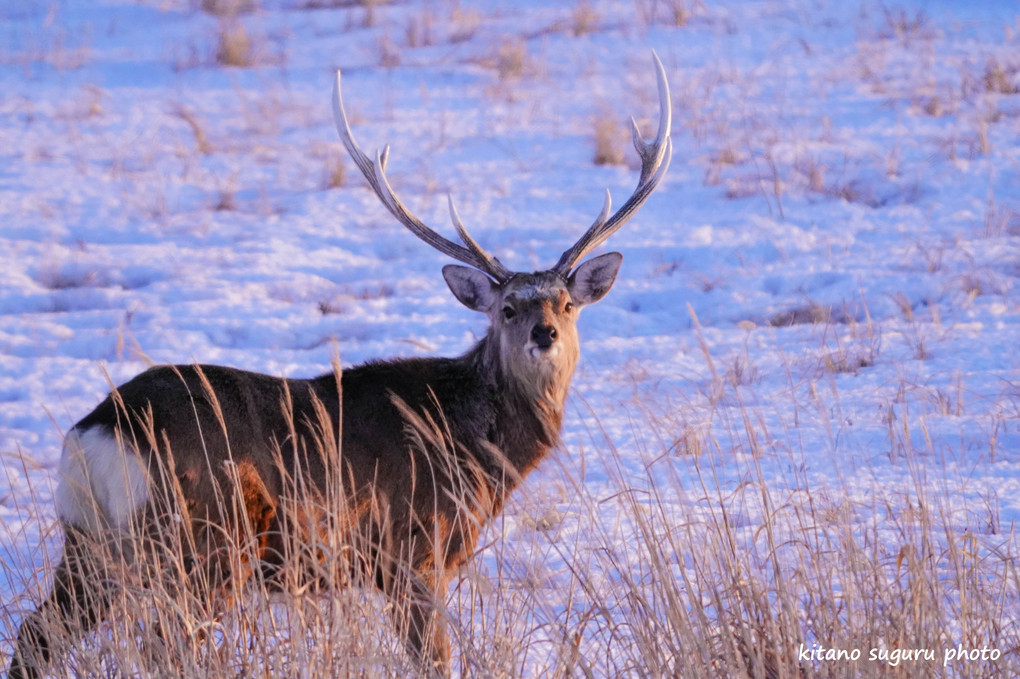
[334,52,672,405]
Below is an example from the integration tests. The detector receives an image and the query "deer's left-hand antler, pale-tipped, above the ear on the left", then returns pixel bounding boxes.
[333,70,513,282]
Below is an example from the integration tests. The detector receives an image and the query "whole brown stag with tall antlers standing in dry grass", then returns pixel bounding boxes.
[8,52,672,679]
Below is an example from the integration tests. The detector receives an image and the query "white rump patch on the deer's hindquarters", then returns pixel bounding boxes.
[54,426,149,532]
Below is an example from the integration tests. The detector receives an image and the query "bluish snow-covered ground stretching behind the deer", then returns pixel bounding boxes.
[0,0,1020,672]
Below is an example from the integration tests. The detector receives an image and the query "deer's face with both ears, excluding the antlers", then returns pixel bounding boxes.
[443,252,623,395]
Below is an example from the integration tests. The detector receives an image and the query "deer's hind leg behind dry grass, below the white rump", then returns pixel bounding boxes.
[7,525,108,679]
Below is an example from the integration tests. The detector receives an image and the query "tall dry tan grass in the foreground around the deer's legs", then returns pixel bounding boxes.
[0,356,1020,679]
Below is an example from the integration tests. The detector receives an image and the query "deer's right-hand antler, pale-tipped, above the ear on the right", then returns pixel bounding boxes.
[553,52,673,275]
